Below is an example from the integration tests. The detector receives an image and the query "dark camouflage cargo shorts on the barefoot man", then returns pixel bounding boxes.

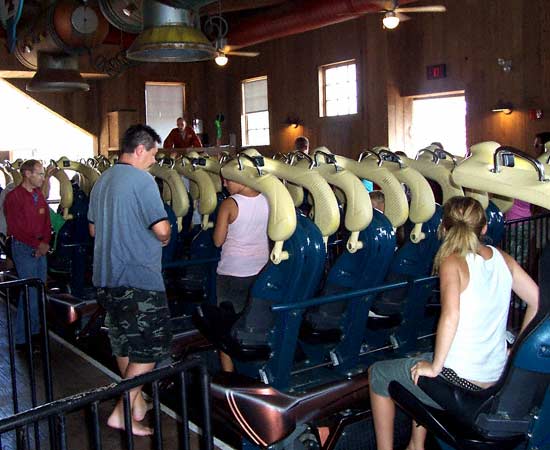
[98,287,172,363]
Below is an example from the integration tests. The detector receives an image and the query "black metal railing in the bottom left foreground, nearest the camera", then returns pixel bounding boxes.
[0,358,213,450]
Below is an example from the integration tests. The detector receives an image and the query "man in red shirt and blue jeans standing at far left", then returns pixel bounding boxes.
[4,159,51,349]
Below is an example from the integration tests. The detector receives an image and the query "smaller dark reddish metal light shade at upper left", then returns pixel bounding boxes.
[26,52,90,92]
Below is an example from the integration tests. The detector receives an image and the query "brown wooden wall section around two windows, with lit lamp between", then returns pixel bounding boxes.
[208,13,387,155]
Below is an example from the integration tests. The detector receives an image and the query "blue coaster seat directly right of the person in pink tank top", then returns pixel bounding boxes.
[193,212,326,384]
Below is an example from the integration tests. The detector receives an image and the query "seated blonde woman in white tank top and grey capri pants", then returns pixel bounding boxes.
[369,197,539,450]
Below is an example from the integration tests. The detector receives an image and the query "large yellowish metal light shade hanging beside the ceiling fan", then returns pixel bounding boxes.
[126,0,217,62]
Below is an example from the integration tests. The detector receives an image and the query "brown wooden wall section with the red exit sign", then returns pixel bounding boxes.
[388,0,550,156]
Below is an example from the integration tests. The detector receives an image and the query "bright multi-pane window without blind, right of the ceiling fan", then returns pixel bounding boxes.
[319,60,357,117]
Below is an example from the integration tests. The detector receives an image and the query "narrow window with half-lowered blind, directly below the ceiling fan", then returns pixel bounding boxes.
[241,77,269,147]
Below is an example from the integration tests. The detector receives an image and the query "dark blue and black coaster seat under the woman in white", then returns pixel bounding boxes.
[390,246,550,450]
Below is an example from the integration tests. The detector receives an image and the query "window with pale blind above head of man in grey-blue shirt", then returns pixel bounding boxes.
[145,82,185,140]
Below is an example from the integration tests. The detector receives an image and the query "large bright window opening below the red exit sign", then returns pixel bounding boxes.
[409,93,466,157]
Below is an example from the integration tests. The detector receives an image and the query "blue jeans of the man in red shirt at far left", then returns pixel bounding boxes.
[11,239,47,344]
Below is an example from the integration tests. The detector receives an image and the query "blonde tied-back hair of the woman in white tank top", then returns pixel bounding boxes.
[433,197,487,274]
